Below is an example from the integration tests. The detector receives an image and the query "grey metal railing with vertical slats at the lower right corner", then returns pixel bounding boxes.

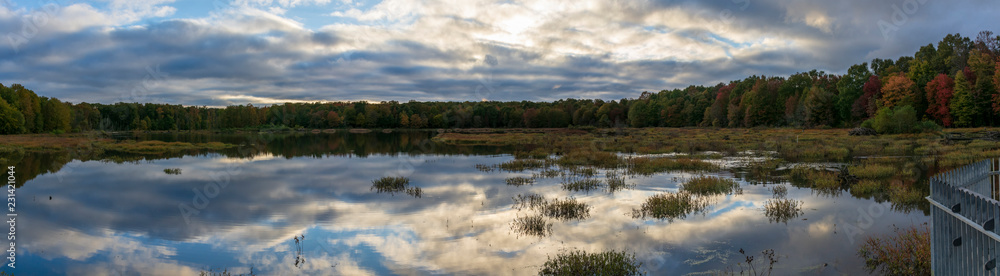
[927,159,1000,275]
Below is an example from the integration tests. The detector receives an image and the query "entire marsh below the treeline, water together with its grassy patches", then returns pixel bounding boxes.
[0,128,1000,275]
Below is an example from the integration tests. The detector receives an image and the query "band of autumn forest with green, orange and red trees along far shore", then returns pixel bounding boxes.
[0,31,1000,134]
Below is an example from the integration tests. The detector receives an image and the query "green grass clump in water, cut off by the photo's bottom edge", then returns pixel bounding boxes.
[538,250,644,275]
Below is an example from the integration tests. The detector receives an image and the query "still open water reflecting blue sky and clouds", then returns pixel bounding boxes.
[2,132,927,275]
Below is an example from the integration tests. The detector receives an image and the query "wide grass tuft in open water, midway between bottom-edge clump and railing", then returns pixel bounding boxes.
[632,191,708,221]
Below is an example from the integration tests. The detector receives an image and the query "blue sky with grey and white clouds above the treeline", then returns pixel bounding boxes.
[0,0,1000,106]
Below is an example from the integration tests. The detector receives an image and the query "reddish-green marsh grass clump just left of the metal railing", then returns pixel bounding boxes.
[858,224,931,275]
